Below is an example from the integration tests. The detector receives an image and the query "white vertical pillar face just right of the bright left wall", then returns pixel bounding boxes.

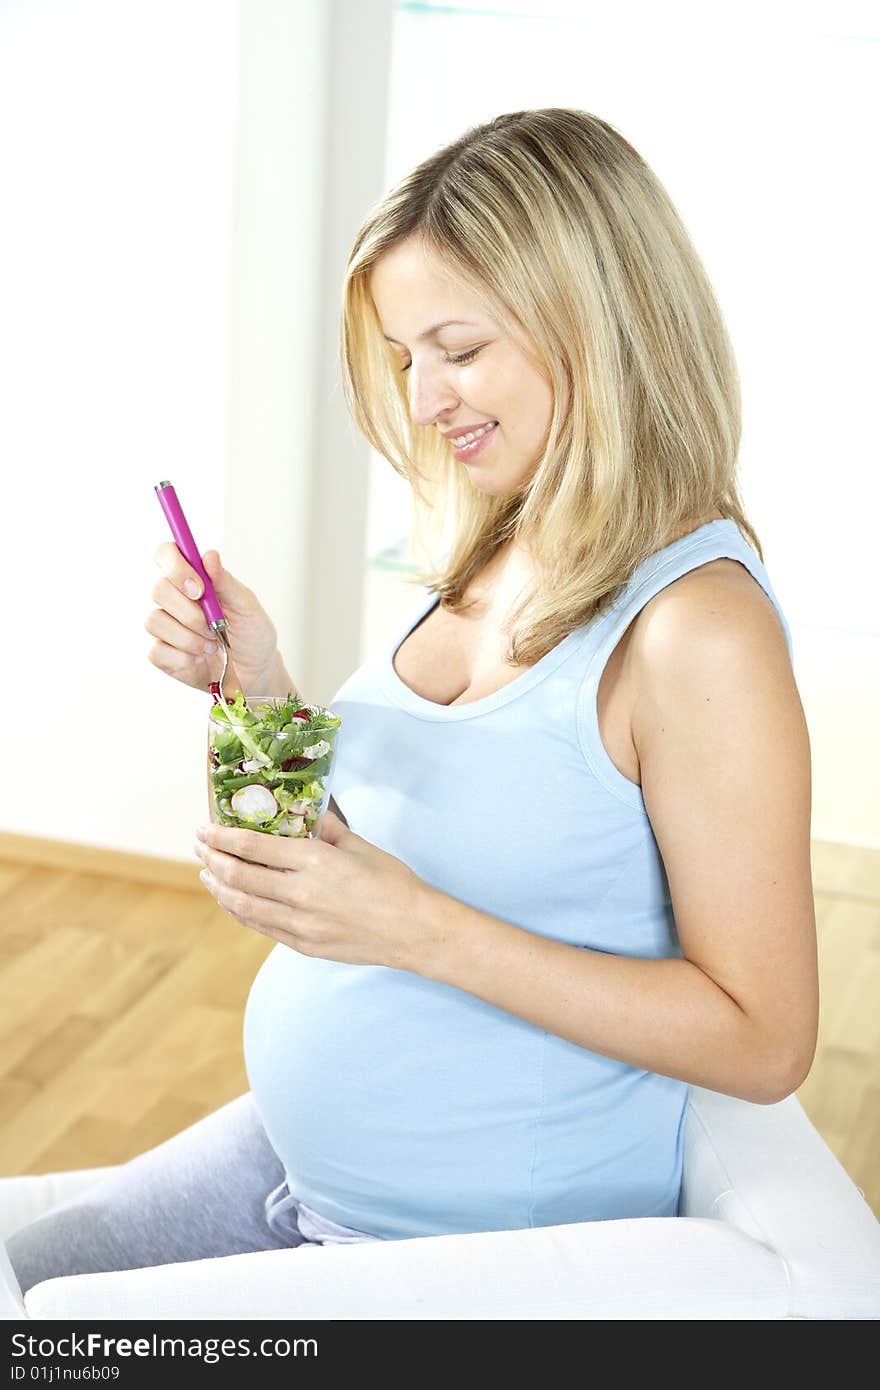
[225,0,331,708]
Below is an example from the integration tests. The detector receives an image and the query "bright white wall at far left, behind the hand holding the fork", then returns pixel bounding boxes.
[0,0,238,858]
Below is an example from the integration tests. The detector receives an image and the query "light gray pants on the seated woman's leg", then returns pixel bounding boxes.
[6,1091,375,1294]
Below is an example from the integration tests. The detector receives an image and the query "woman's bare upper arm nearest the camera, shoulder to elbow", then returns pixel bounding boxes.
[633,570,819,1090]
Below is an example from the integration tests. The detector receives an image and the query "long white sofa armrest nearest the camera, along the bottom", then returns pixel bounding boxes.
[25,1216,788,1321]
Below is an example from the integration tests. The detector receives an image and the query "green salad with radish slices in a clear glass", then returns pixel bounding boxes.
[207,691,342,838]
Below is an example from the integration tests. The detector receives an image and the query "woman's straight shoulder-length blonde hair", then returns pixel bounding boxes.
[341,107,763,666]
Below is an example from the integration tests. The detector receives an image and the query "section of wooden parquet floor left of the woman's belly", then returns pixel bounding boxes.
[0,860,272,1175]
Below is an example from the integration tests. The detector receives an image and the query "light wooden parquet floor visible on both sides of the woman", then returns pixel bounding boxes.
[0,837,880,1216]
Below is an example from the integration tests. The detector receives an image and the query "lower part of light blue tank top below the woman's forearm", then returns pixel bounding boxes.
[245,945,687,1238]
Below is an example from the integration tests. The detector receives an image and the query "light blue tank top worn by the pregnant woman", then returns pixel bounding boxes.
[245,520,791,1240]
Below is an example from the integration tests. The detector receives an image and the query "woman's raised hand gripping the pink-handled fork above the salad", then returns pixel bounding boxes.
[143,541,286,695]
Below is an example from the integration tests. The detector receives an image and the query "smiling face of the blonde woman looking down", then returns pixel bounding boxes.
[370,238,553,498]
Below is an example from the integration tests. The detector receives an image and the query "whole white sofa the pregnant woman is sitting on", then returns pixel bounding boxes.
[0,1087,880,1321]
